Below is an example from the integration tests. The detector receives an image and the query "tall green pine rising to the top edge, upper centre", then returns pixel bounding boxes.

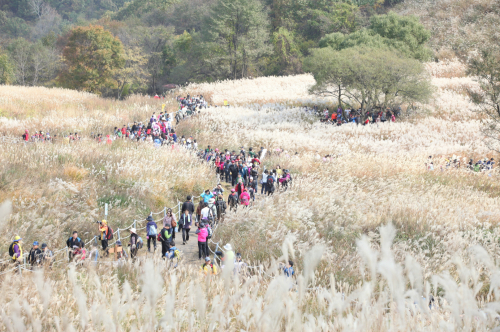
[205,0,270,79]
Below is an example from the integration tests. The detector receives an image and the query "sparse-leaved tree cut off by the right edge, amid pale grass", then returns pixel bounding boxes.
[467,44,500,152]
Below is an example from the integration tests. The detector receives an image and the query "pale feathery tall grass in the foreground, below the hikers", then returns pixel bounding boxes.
[0,224,500,331]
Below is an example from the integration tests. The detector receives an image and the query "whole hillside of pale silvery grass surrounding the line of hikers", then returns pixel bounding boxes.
[0,62,500,331]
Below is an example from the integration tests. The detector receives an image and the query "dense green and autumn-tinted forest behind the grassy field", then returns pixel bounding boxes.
[0,0,433,99]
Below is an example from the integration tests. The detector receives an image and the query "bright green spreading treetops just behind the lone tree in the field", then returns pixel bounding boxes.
[319,12,432,61]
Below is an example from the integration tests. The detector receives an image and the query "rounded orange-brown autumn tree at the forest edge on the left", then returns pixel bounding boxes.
[58,25,125,94]
